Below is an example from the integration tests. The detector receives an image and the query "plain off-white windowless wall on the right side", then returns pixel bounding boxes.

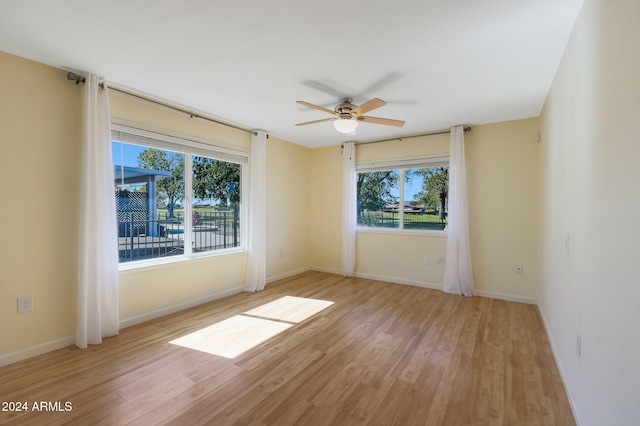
[538,0,640,425]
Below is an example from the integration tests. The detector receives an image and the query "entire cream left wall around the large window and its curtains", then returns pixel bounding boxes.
[0,52,311,365]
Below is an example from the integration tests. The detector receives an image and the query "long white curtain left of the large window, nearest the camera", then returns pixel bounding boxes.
[76,75,119,349]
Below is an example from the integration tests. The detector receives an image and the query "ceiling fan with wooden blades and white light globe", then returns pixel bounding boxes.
[296,98,404,133]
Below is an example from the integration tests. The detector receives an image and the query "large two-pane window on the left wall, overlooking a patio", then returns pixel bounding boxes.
[112,124,247,264]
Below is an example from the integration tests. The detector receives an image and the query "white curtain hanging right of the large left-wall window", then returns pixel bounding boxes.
[244,130,267,292]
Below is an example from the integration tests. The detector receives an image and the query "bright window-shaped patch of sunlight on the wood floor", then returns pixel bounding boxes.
[169,296,333,359]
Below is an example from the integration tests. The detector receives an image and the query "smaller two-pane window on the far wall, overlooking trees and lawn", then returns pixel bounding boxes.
[356,157,449,231]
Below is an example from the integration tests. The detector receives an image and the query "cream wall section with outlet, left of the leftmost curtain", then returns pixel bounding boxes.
[0,52,81,360]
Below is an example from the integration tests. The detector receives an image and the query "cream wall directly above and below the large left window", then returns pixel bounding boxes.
[109,91,251,325]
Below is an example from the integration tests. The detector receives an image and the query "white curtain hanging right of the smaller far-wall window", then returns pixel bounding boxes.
[443,126,474,296]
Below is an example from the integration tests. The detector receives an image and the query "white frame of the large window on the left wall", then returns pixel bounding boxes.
[111,121,249,271]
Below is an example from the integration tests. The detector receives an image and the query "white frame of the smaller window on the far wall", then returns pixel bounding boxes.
[355,154,450,237]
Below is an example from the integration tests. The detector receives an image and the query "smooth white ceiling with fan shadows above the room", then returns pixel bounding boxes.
[0,0,582,147]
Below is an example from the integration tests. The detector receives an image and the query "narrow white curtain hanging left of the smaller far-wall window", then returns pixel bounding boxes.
[342,142,357,277]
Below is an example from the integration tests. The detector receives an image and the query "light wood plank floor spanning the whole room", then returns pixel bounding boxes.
[0,272,575,426]
